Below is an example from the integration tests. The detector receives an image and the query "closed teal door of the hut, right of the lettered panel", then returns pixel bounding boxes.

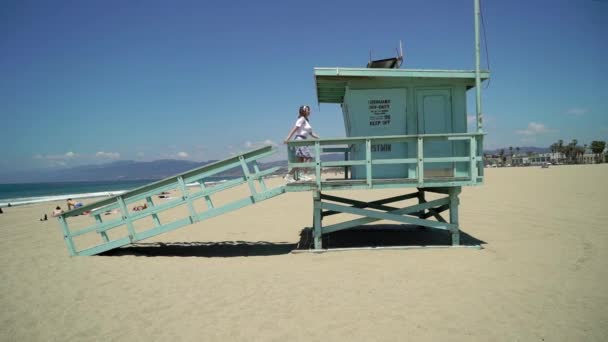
[416,89,454,178]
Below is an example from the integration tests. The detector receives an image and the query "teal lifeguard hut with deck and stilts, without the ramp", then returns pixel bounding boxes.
[286,65,489,248]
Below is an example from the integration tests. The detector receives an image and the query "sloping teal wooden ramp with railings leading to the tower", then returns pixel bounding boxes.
[58,146,285,255]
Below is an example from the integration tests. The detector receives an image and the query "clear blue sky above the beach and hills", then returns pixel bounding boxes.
[0,0,608,173]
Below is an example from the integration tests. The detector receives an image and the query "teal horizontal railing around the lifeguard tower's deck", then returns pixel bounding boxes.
[288,133,483,189]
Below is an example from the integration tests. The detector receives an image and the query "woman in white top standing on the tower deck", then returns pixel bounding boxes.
[284,105,319,183]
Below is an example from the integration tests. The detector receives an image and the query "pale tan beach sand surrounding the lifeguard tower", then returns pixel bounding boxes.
[0,165,608,341]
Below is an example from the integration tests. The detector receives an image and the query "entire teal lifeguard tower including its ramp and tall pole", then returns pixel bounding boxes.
[54,0,489,255]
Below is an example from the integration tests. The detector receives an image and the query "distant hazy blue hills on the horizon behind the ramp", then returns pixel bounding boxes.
[0,154,344,183]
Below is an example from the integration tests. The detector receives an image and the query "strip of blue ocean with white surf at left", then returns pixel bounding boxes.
[0,177,233,208]
